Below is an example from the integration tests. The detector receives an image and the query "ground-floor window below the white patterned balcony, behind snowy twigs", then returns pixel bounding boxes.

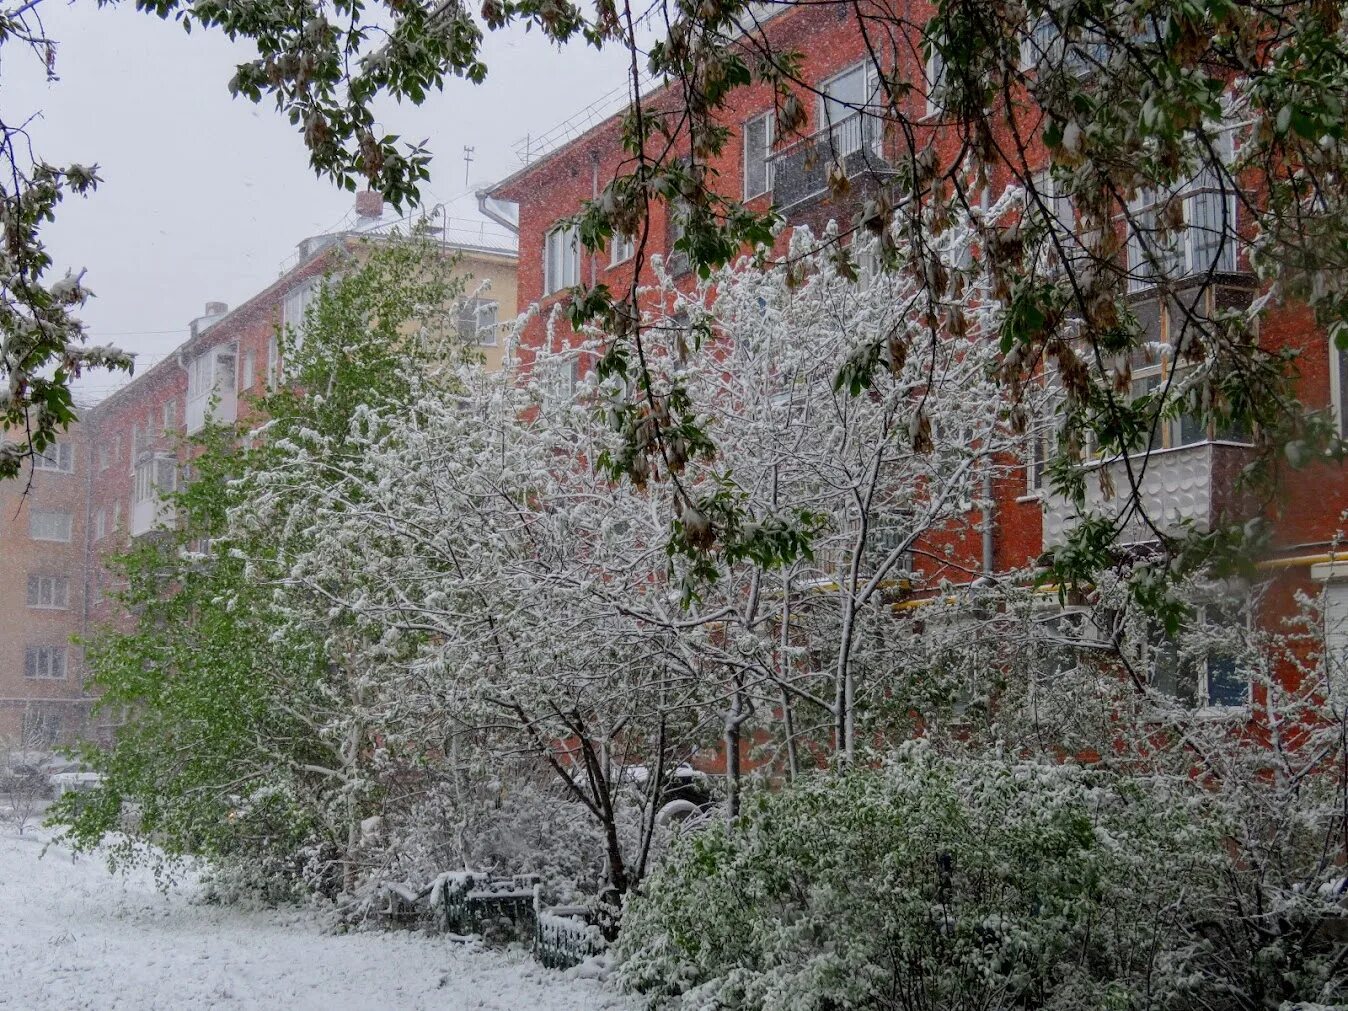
[1148,601,1250,708]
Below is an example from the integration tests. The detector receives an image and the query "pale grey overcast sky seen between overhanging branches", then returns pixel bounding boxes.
[0,0,625,400]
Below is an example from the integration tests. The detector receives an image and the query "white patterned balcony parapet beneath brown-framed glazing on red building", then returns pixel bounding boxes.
[1043,441,1250,550]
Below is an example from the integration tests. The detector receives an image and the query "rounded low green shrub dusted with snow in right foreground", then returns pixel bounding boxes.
[617,744,1342,1011]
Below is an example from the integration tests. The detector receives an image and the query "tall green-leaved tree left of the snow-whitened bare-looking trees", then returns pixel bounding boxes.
[54,239,479,894]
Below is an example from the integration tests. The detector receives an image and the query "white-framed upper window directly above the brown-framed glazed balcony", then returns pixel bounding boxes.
[1128,129,1236,291]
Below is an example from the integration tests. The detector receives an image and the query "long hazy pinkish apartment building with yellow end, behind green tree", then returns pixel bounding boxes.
[0,193,516,751]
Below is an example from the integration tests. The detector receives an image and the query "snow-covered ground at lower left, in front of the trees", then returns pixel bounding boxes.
[0,826,630,1011]
